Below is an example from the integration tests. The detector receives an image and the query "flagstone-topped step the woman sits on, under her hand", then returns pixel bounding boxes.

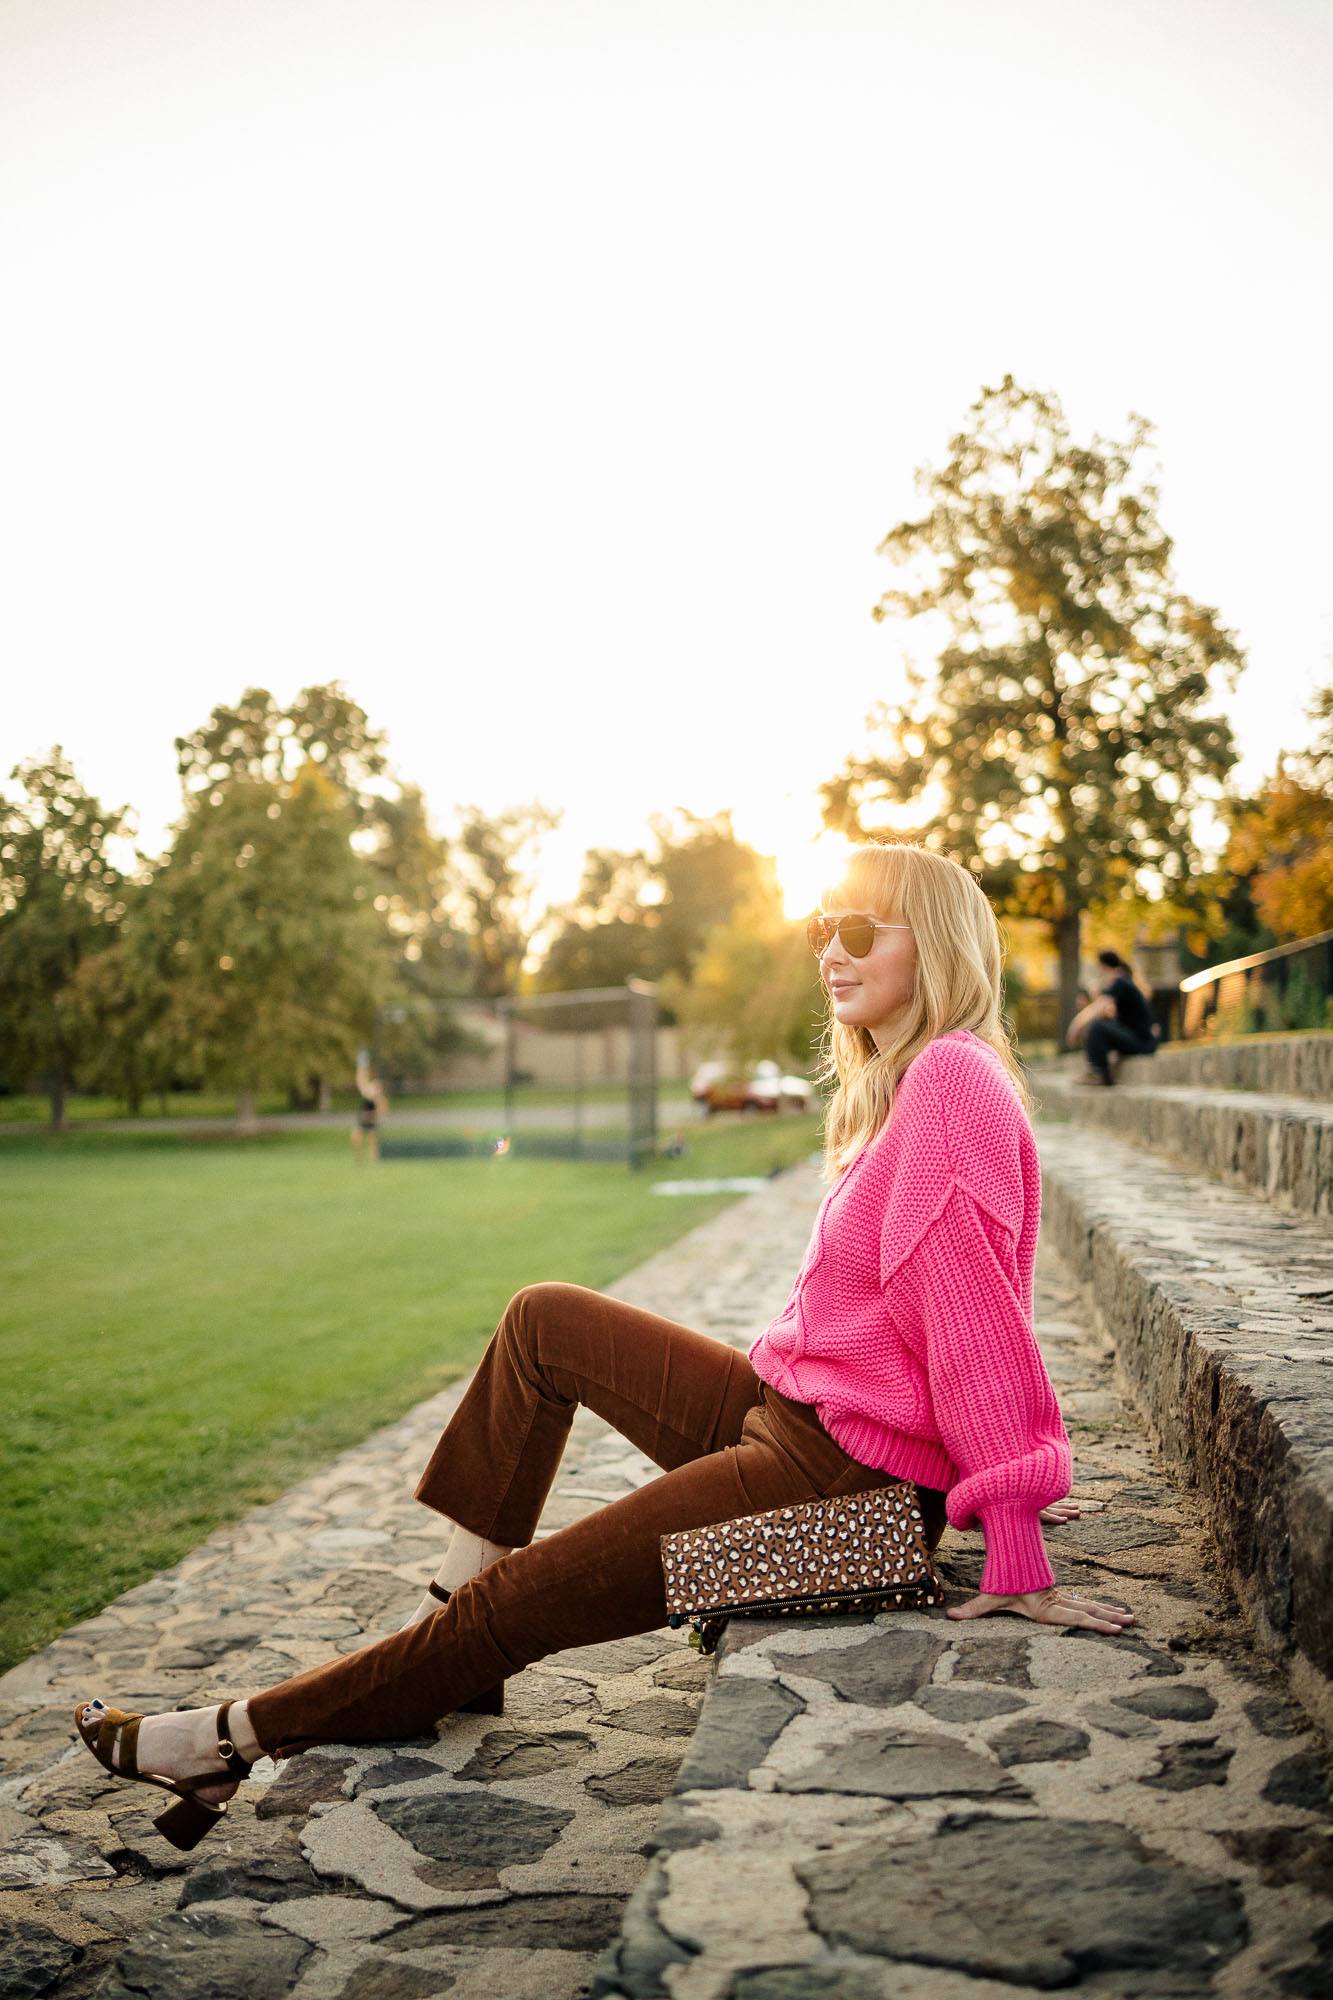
[592,1200,1333,2000]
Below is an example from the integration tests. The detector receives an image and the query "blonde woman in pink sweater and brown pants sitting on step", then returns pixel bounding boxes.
[76,844,1133,1846]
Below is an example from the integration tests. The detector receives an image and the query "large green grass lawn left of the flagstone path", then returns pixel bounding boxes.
[0,1116,819,1668]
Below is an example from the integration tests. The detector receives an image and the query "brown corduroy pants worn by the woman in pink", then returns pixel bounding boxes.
[248,1284,945,1756]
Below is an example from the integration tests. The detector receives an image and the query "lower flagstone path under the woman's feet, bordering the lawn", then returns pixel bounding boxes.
[0,1168,821,2000]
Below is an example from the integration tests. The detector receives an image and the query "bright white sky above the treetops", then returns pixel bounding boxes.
[0,0,1333,908]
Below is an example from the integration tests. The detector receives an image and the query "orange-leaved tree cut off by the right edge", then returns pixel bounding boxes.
[1227,682,1333,940]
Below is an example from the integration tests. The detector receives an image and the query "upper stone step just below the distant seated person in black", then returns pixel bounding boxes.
[1033,1052,1333,1220]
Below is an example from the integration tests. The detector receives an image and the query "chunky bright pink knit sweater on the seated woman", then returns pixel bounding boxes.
[751,1030,1073,1594]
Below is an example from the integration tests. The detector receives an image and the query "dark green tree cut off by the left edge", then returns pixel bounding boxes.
[0,746,124,1128]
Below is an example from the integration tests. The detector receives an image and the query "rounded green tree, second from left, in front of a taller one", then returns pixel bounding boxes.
[105,764,392,1124]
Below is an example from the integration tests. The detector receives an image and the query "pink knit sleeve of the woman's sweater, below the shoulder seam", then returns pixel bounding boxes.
[895,1184,1073,1596]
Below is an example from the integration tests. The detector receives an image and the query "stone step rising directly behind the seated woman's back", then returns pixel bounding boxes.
[1039,1120,1333,1724]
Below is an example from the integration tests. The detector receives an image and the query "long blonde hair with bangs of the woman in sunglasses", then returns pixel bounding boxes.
[819,840,1031,1180]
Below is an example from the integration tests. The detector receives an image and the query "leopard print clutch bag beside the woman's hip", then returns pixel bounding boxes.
[662,1480,945,1652]
